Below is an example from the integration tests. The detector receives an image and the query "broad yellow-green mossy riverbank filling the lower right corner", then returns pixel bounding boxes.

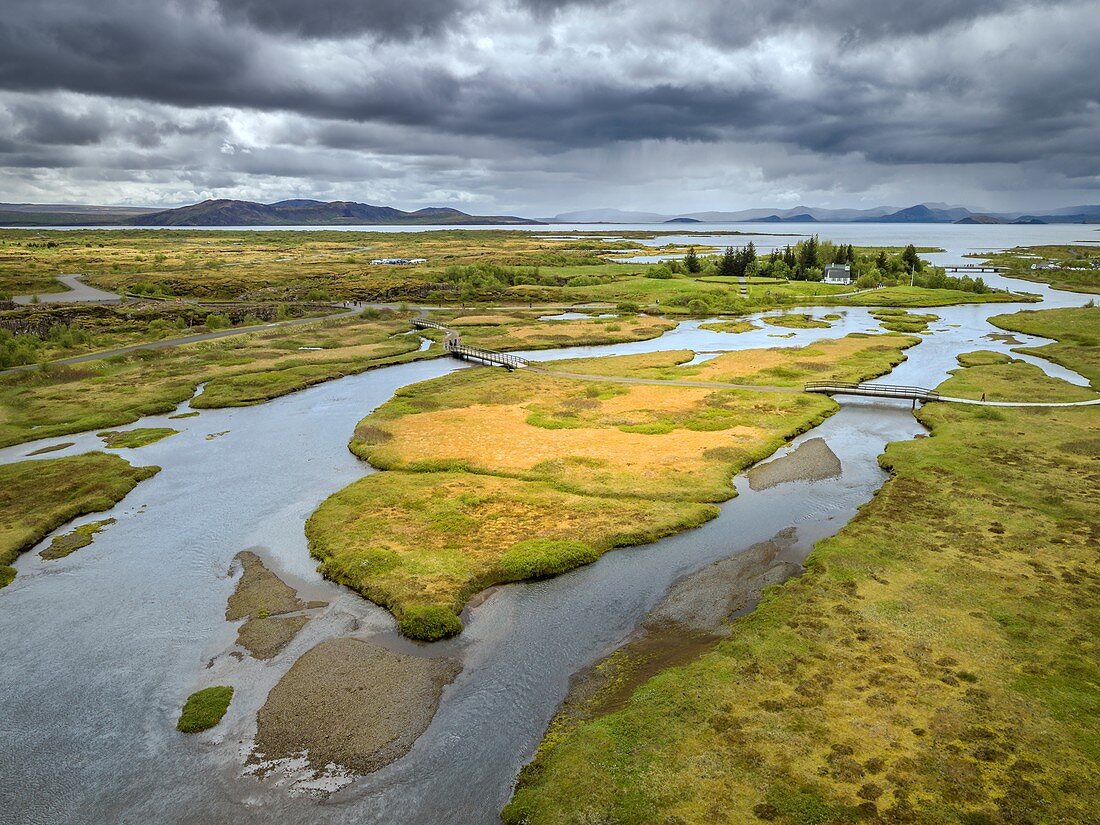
[505,309,1100,825]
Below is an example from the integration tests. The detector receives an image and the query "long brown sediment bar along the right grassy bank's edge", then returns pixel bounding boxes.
[547,536,802,740]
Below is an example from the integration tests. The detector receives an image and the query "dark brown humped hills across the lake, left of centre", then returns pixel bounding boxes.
[129,199,539,227]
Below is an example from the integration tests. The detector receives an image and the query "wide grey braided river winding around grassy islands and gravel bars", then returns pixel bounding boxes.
[0,224,1090,825]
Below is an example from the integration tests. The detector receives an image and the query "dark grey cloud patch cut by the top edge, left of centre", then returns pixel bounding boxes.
[217,0,466,40]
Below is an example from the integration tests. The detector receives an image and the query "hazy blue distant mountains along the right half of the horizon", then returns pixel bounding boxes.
[546,204,1100,223]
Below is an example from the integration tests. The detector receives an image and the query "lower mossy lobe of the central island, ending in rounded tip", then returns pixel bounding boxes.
[306,471,717,640]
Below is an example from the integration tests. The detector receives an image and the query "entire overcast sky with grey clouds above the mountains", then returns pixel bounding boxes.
[0,0,1100,217]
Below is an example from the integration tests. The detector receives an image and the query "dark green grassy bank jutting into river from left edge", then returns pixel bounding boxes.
[0,452,161,587]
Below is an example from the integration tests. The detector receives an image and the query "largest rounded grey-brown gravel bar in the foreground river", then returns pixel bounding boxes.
[254,638,462,774]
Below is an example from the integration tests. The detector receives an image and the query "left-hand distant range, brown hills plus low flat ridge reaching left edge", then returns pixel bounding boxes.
[0,199,540,227]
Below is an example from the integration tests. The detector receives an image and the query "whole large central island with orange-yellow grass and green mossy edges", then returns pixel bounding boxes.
[307,336,915,639]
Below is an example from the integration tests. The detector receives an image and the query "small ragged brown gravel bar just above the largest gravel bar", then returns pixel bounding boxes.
[226,550,327,659]
